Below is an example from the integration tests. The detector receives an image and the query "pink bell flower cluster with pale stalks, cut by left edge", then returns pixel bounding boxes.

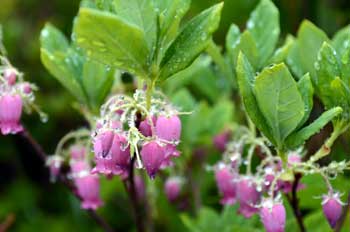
[0,62,40,135]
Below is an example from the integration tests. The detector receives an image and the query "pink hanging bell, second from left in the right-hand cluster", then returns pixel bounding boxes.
[236,178,261,218]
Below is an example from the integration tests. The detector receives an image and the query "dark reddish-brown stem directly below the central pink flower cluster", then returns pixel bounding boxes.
[124,155,146,232]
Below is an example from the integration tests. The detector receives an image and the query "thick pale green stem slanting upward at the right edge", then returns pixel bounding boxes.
[309,122,349,163]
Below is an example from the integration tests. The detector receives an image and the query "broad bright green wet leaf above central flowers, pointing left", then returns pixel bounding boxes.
[74,8,149,76]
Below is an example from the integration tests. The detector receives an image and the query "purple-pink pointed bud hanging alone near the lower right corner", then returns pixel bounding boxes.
[322,192,343,228]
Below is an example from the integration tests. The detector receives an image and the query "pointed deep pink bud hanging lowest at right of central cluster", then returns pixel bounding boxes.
[141,141,165,179]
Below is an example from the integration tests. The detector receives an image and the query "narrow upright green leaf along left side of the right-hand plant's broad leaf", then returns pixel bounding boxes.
[236,52,276,144]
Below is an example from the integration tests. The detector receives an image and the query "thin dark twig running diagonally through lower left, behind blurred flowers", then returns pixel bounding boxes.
[19,129,115,232]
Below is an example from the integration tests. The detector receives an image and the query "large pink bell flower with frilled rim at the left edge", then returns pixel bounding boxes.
[0,95,23,135]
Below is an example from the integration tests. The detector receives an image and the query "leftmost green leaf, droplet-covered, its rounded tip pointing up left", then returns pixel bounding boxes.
[40,24,86,101]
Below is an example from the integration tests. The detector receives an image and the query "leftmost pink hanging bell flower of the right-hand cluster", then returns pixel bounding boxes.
[215,164,236,205]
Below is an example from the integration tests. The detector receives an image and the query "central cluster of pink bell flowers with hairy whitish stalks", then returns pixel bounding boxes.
[92,90,181,179]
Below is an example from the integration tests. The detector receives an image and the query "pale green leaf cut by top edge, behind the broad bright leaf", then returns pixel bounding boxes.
[114,0,157,50]
